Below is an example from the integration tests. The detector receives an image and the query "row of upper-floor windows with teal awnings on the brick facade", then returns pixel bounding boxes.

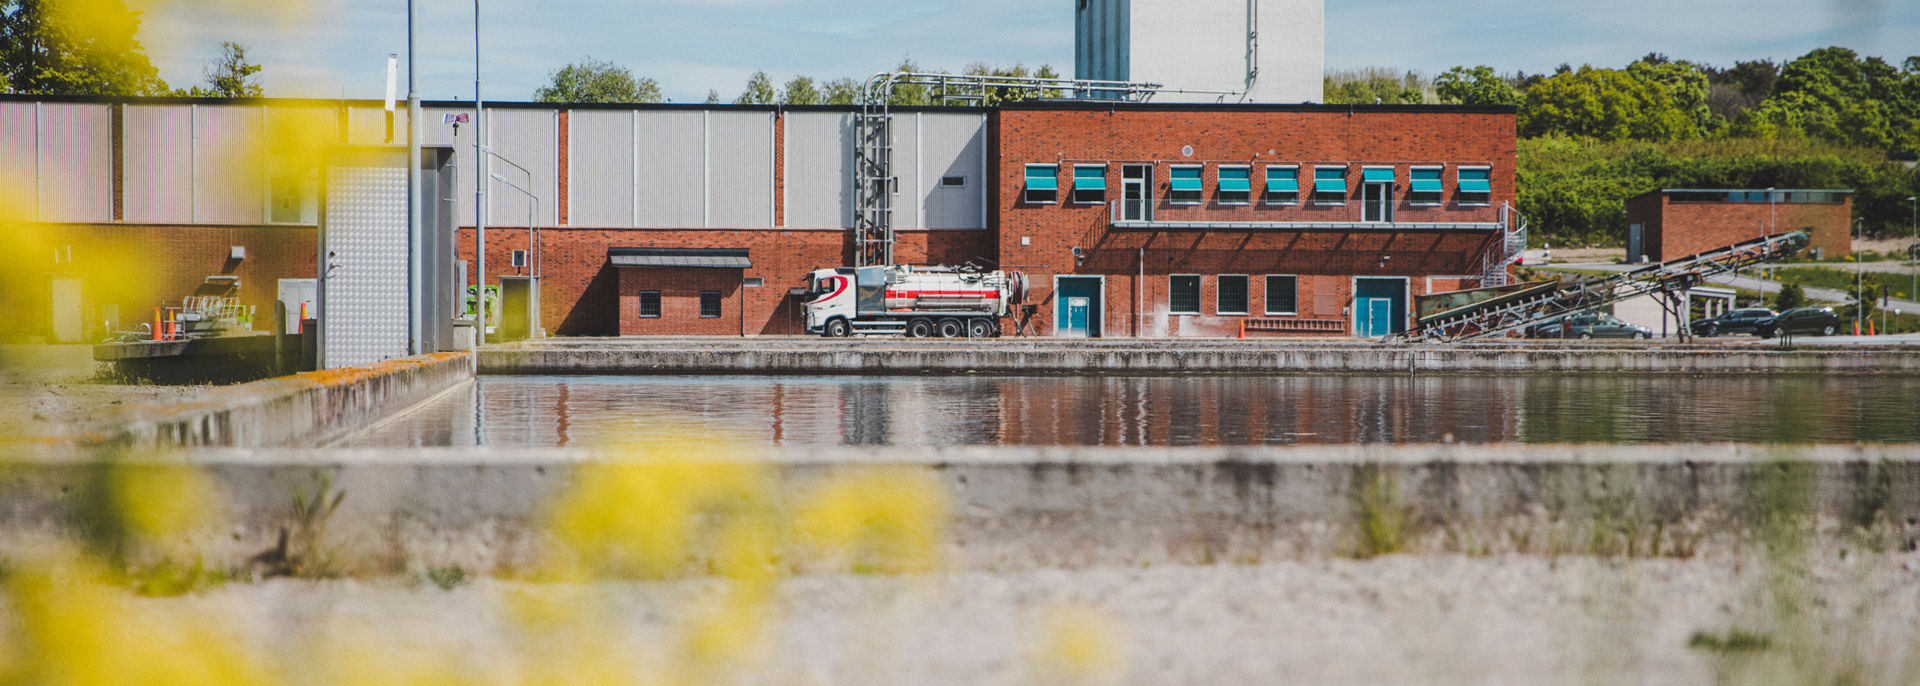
[1023,163,1494,206]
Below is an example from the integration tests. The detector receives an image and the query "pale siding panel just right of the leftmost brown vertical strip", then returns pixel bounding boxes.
[121,106,194,223]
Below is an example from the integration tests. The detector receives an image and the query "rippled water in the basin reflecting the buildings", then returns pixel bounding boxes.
[349,377,1920,446]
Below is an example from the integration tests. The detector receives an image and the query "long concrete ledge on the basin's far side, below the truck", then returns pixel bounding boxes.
[478,338,1920,375]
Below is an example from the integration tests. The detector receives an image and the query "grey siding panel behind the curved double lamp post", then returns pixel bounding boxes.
[486,108,559,227]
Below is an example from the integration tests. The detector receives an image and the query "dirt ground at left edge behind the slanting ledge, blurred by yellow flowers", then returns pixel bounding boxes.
[0,346,207,442]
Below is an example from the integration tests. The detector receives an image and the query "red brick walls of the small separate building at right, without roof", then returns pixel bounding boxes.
[1626,194,1853,261]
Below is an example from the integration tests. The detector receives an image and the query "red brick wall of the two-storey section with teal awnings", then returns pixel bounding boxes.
[993,108,1515,336]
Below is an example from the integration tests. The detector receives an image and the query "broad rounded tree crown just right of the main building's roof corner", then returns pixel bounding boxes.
[1519,67,1699,140]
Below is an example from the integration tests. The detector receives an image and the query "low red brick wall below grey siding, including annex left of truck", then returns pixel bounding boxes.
[461,227,993,336]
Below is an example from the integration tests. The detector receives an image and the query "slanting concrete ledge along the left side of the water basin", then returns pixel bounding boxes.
[64,352,474,448]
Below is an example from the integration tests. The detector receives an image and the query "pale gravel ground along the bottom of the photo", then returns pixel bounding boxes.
[97,553,1920,684]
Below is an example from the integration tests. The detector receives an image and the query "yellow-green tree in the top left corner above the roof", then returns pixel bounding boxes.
[0,0,169,96]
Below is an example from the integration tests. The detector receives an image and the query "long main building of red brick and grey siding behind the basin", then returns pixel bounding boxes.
[0,96,1515,340]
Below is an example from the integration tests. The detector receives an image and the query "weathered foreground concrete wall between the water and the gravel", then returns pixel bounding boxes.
[0,444,1920,569]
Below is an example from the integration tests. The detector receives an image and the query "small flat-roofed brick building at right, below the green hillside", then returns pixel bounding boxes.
[1626,188,1853,261]
